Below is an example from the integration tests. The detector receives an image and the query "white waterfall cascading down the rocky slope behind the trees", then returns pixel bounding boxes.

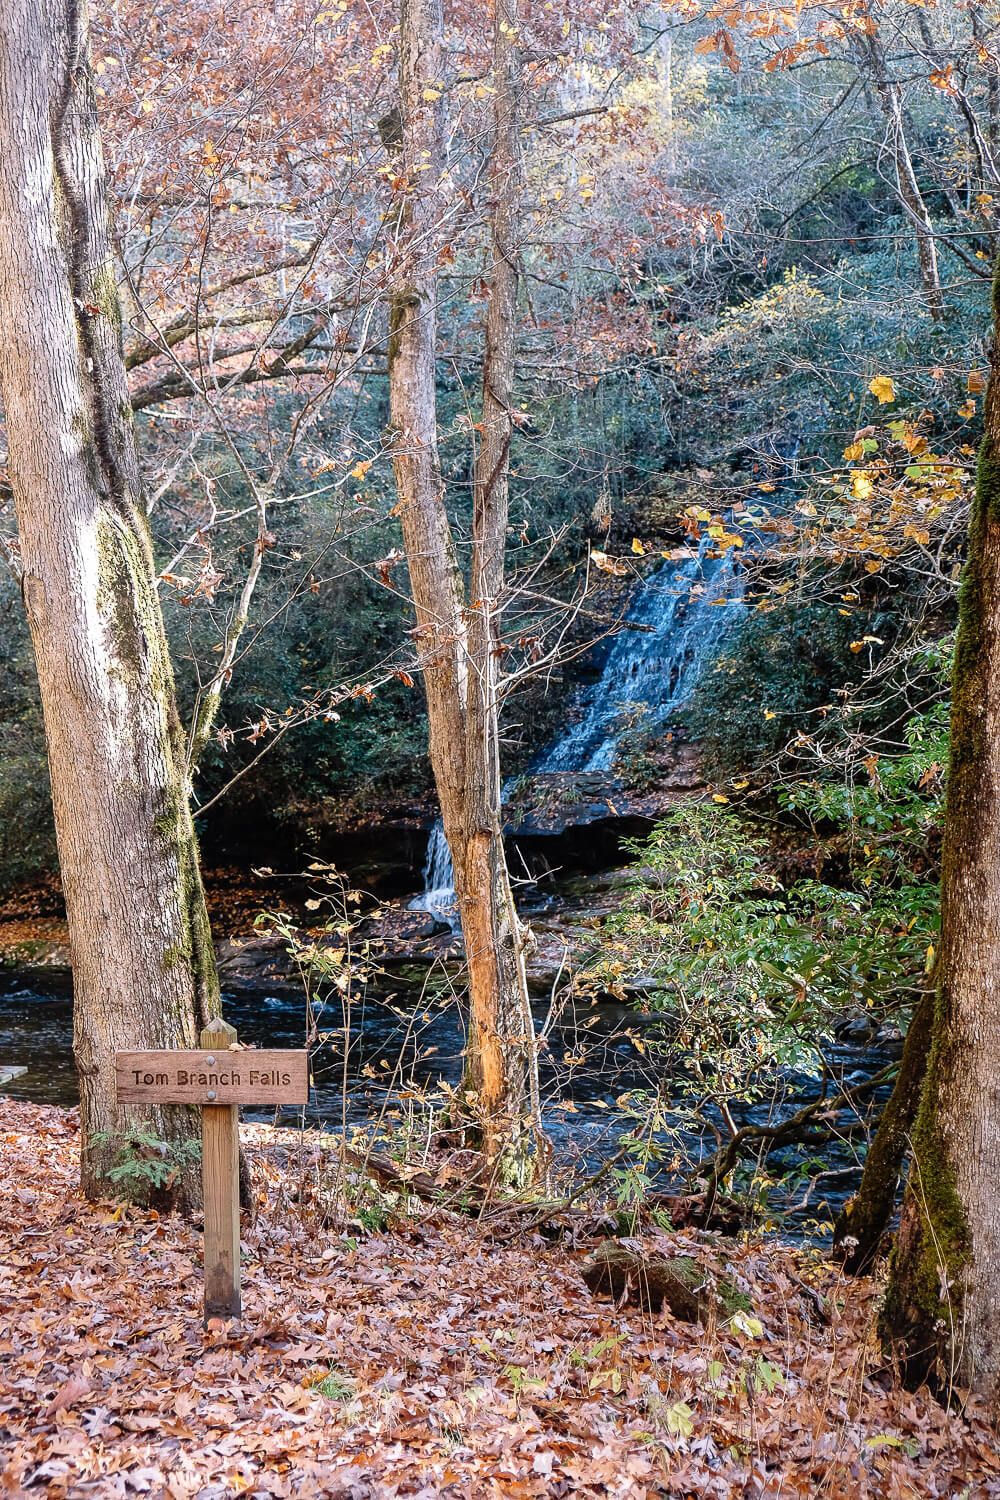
[409,537,744,926]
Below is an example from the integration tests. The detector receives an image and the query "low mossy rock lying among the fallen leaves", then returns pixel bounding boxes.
[583,1239,750,1323]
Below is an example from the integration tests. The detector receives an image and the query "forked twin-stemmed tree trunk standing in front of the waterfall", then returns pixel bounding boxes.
[388,0,537,1160]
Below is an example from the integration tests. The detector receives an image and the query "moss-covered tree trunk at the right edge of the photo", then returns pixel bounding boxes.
[885,258,1000,1404]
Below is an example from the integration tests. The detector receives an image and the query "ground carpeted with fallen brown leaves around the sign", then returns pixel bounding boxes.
[0,1098,1000,1500]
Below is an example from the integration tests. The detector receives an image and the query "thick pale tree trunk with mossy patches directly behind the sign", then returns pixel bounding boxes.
[0,0,219,1196]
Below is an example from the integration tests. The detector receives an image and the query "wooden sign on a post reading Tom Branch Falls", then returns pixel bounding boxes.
[115,1020,309,1326]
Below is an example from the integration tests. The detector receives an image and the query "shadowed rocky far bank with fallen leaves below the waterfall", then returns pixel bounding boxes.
[0,741,705,993]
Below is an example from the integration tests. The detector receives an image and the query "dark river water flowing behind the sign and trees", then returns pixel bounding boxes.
[0,969,891,1238]
